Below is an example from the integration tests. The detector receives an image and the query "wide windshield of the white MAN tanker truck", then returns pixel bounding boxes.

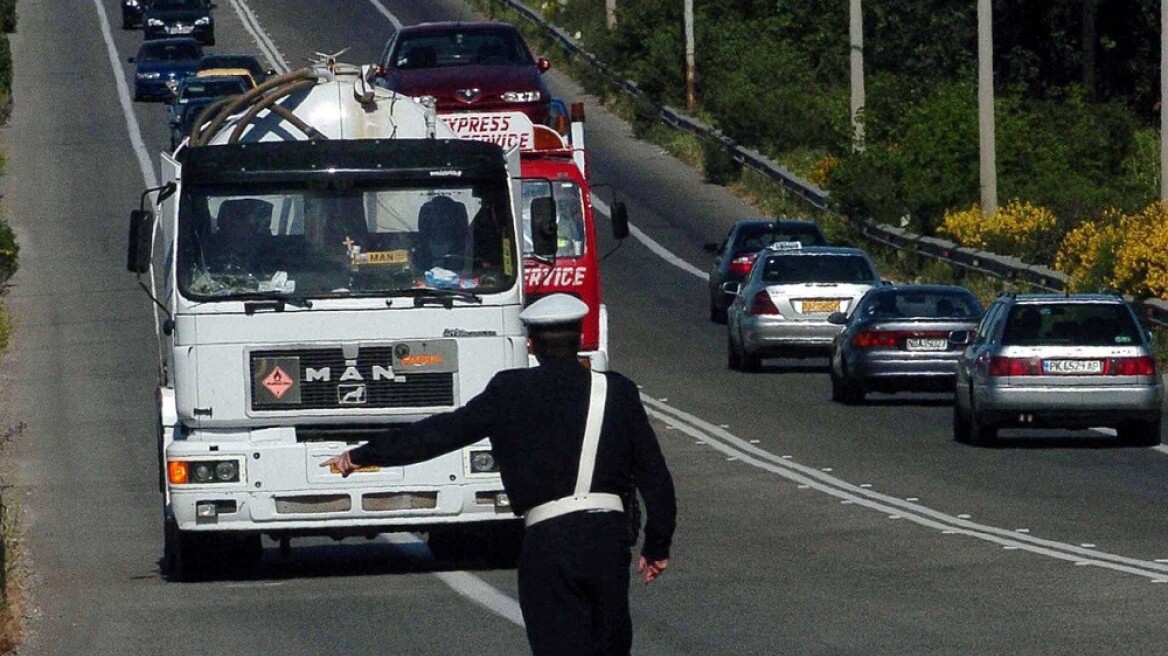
[178,177,517,300]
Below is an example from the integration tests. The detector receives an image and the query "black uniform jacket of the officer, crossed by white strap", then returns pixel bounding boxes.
[350,360,677,559]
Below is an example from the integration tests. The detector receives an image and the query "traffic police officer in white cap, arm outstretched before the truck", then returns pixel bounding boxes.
[322,294,676,656]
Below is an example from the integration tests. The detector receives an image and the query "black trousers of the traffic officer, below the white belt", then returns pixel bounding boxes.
[519,512,633,656]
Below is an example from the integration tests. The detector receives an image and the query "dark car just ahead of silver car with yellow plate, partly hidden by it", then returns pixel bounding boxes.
[704,218,827,323]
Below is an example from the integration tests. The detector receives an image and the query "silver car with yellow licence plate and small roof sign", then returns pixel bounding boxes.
[723,242,883,371]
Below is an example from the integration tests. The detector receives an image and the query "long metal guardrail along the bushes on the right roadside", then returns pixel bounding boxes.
[492,0,1168,326]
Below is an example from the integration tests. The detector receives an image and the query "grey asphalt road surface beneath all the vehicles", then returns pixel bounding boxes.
[0,0,1168,656]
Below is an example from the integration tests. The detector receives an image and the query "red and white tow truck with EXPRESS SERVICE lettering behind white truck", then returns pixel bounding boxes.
[440,103,628,364]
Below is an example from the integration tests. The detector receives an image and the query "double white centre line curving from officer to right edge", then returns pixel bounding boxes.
[641,395,1168,580]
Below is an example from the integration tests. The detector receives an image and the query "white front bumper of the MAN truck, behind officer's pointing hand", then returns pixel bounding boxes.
[166,434,515,536]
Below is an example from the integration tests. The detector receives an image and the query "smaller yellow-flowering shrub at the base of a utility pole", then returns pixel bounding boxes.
[937,201,1058,264]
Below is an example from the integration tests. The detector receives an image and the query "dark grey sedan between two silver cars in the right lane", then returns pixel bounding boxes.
[827,285,983,404]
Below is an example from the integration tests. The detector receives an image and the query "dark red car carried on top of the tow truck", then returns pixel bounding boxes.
[371,22,551,125]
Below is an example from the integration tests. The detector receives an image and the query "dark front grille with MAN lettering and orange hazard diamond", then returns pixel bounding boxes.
[250,346,454,411]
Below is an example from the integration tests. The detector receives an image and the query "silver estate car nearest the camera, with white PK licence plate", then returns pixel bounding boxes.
[953,294,1163,446]
